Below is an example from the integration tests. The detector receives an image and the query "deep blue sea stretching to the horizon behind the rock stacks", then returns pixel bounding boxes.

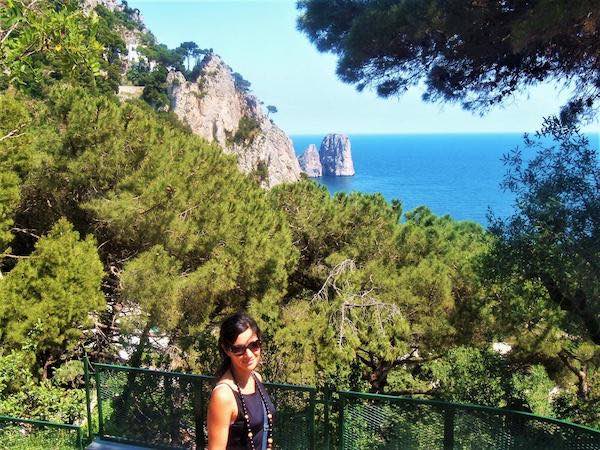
[292,134,597,226]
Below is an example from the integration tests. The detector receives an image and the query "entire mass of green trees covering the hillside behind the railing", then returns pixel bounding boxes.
[0,0,600,426]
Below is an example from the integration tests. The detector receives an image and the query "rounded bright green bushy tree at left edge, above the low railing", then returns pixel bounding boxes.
[0,219,104,371]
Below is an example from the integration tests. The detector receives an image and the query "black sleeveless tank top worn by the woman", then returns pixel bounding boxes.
[217,377,275,450]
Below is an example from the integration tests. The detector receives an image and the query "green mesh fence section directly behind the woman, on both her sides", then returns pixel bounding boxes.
[91,364,315,450]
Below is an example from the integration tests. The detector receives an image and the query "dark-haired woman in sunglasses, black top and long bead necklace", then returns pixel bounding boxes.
[207,313,275,450]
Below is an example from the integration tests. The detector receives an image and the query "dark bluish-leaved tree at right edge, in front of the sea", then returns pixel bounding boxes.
[489,119,600,344]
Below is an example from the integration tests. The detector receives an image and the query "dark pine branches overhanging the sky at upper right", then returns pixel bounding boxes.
[298,0,600,111]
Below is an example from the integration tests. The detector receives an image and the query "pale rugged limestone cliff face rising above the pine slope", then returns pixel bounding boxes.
[167,54,300,187]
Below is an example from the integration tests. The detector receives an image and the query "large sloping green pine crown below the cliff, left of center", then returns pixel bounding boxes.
[0,82,295,360]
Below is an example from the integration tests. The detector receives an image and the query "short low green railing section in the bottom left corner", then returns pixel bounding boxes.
[0,416,83,450]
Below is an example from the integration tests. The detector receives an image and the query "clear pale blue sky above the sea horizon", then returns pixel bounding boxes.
[128,0,597,134]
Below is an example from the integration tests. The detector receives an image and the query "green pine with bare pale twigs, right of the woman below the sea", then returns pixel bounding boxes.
[272,181,487,392]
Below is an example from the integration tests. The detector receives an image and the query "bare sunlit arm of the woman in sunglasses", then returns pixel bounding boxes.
[207,387,235,450]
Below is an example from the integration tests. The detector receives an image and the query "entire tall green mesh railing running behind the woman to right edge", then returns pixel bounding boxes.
[85,361,600,450]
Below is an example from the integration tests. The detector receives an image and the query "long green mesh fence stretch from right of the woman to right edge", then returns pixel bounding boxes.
[338,392,600,450]
